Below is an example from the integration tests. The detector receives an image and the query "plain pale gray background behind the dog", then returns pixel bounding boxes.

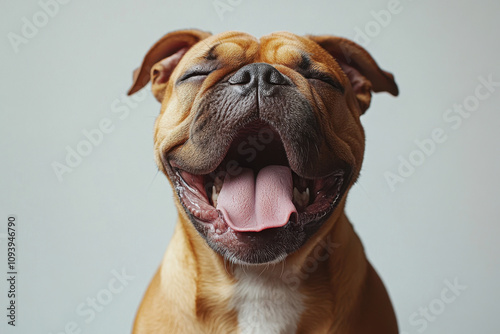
[0,0,500,334]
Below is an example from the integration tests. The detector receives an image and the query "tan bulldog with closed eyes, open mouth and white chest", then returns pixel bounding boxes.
[129,29,398,334]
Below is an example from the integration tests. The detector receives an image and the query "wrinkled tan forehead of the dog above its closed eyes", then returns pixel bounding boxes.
[186,32,324,64]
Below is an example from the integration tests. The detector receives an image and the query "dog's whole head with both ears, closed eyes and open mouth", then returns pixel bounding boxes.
[129,30,397,263]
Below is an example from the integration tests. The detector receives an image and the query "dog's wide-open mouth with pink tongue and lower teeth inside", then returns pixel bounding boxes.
[170,122,345,236]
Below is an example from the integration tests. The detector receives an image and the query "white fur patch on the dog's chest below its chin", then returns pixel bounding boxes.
[231,268,304,334]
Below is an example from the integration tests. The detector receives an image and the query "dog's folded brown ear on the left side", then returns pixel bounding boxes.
[128,29,211,102]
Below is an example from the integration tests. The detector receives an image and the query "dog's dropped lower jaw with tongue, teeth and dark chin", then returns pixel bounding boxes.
[165,124,350,264]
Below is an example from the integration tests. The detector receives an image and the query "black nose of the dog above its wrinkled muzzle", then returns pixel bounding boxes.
[229,63,291,96]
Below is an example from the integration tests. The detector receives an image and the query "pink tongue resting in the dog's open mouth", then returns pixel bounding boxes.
[217,166,297,232]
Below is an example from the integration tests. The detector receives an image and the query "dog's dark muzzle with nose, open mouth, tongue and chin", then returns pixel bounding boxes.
[164,63,350,263]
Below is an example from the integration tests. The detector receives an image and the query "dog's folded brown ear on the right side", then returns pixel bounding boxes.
[307,35,399,113]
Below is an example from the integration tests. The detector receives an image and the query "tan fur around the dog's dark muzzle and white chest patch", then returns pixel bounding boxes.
[131,30,398,334]
